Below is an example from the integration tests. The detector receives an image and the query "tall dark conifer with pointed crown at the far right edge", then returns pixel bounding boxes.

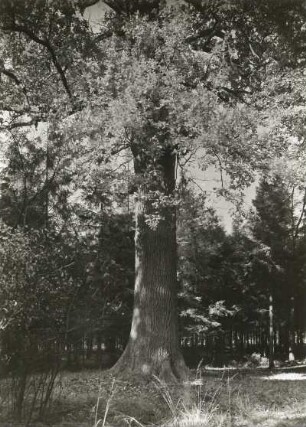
[250,174,304,357]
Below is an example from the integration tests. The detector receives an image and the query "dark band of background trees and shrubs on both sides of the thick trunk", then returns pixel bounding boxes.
[0,169,306,373]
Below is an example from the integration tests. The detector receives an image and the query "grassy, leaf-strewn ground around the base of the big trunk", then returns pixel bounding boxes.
[0,368,306,427]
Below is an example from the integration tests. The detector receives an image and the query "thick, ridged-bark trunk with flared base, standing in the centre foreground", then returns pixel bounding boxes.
[113,151,187,381]
